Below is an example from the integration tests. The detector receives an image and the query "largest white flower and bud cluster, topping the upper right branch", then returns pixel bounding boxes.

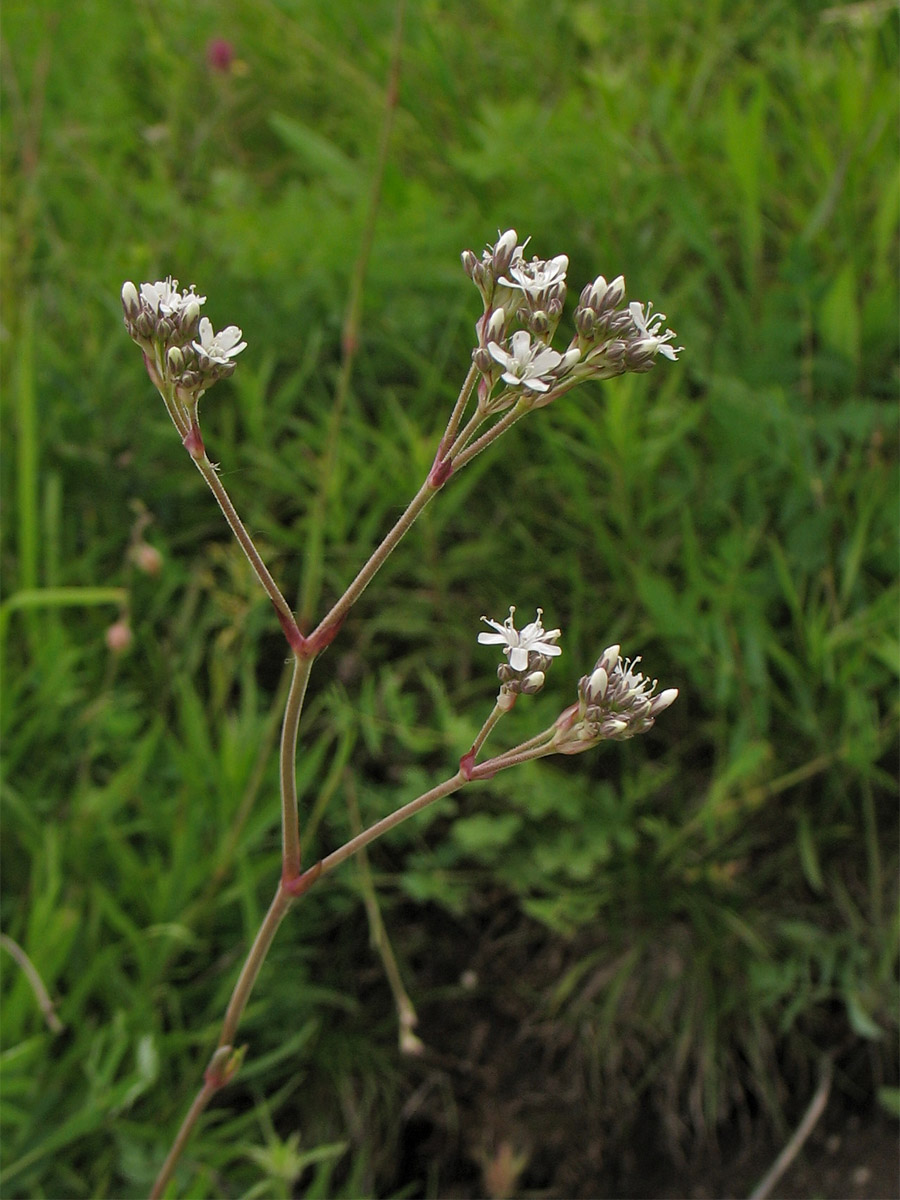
[462,229,682,413]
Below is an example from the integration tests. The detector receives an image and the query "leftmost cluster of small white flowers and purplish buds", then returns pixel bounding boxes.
[122,276,247,410]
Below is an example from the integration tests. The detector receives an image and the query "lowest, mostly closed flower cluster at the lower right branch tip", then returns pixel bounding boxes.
[553,646,678,754]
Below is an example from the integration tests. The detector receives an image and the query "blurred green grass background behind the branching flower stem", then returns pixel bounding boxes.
[0,0,900,1198]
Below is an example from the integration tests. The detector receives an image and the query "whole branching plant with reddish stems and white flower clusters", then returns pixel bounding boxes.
[122,229,680,1196]
